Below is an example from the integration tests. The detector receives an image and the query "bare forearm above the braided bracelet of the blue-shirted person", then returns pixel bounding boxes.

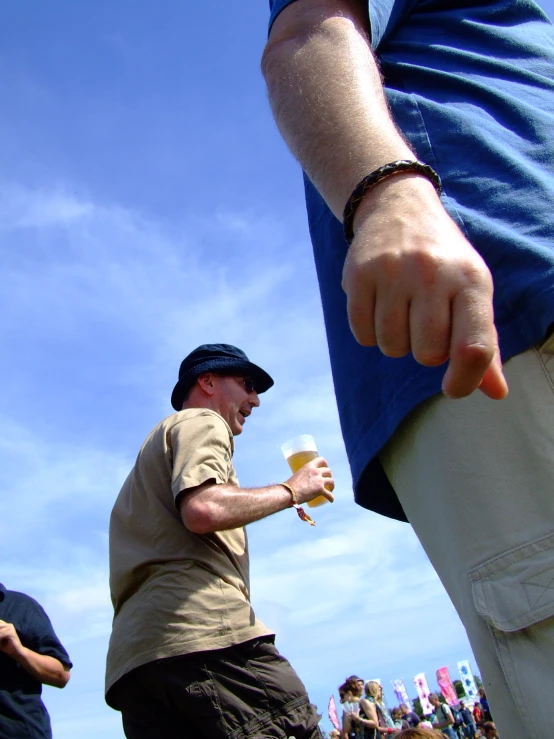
[262,0,414,220]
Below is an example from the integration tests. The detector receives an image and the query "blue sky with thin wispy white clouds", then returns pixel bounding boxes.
[0,0,552,739]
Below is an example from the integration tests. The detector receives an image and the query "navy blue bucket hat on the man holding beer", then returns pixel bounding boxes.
[171,344,273,411]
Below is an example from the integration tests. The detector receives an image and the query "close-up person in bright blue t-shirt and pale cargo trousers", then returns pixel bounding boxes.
[262,0,554,739]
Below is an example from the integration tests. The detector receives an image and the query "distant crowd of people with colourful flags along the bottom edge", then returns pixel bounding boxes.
[330,675,499,739]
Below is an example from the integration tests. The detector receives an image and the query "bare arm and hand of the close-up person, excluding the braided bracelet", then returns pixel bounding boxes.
[262,0,507,398]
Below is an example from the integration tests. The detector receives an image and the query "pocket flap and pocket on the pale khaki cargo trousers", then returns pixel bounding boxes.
[469,534,554,631]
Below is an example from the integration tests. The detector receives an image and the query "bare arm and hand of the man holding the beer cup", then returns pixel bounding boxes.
[180,457,335,534]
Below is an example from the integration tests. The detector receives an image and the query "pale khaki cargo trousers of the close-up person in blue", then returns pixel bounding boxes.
[380,335,554,739]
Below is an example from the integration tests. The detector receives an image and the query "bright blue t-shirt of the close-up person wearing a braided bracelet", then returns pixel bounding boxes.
[270,0,554,520]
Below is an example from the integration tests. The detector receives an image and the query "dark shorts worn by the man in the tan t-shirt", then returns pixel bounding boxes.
[110,637,321,739]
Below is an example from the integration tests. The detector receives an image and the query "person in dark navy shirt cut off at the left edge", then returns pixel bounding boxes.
[0,584,72,739]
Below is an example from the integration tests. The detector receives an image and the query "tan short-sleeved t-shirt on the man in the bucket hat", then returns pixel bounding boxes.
[106,408,272,704]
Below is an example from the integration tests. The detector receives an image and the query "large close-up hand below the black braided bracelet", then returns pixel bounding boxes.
[342,175,508,400]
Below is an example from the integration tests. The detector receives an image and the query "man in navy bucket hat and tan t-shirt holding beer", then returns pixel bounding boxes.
[106,344,334,739]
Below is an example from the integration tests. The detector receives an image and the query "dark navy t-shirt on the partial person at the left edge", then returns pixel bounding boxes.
[0,584,72,739]
